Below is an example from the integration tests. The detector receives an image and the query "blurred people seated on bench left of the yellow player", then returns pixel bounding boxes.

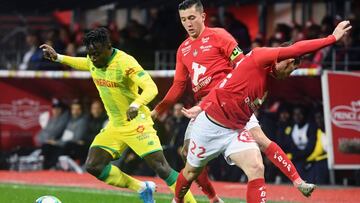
[10,99,108,172]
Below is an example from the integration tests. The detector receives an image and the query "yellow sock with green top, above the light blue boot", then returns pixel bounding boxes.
[98,164,145,192]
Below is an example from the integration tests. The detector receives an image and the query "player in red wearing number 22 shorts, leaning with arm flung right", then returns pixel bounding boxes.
[175,21,351,203]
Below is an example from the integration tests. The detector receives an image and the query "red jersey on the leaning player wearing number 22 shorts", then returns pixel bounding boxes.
[200,35,336,129]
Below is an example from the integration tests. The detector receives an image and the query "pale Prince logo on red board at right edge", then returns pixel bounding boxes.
[331,100,360,132]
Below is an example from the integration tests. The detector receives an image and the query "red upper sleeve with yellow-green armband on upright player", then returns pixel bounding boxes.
[217,29,244,62]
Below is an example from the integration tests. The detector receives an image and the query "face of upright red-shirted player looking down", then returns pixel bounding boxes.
[179,5,205,39]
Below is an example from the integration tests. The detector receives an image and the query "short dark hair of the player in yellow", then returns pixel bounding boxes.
[84,27,110,47]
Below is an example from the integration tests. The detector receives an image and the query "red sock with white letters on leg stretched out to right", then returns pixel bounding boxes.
[265,142,300,183]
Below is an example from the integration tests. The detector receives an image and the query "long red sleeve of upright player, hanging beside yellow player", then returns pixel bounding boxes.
[155,50,189,114]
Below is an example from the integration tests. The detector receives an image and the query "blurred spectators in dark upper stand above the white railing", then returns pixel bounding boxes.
[3,9,360,70]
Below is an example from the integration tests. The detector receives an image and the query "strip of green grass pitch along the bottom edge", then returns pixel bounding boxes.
[0,183,290,203]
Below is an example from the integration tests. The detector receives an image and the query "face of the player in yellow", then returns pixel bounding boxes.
[87,43,111,68]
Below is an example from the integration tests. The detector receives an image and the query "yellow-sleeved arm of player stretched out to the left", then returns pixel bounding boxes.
[40,44,89,70]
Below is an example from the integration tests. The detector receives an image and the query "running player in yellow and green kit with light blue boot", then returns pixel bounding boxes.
[40,28,196,203]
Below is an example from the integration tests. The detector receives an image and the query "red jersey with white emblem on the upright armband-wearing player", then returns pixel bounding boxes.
[155,27,242,113]
